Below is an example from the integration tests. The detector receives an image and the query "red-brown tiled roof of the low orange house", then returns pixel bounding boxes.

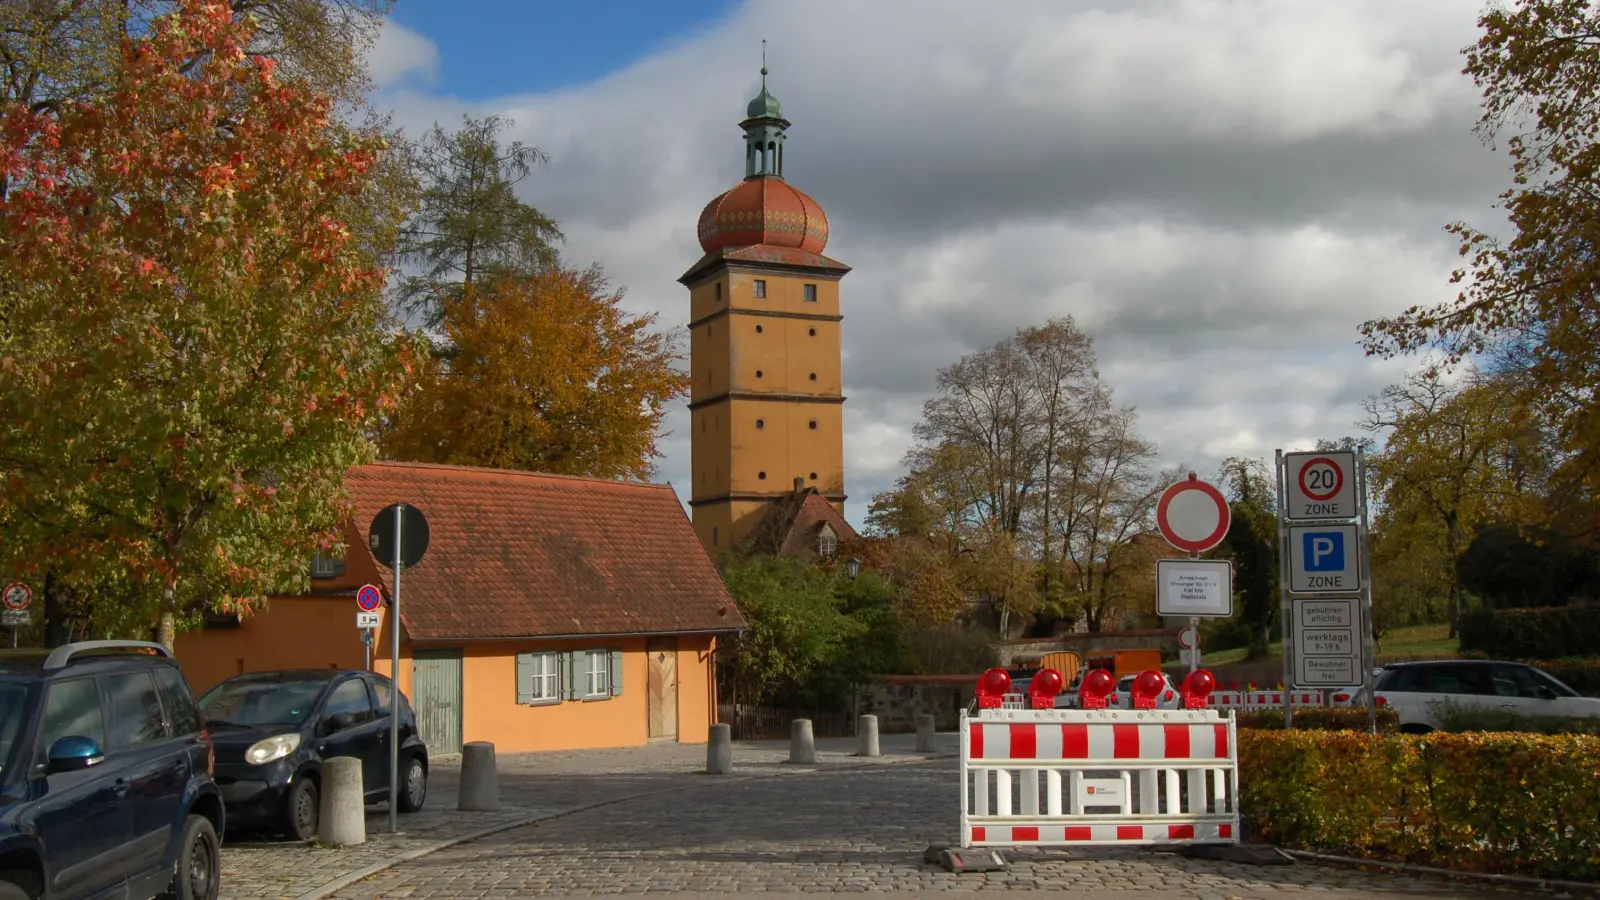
[346,463,744,641]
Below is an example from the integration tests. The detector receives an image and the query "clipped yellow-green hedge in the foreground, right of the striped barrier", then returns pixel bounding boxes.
[1238,729,1600,881]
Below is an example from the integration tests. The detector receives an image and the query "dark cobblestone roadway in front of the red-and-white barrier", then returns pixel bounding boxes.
[334,759,1548,900]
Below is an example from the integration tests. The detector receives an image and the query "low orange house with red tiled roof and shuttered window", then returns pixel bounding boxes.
[174,463,744,753]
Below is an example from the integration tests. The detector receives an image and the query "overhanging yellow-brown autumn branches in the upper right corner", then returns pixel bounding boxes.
[1362,0,1600,490]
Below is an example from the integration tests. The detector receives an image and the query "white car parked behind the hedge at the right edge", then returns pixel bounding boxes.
[1374,660,1600,735]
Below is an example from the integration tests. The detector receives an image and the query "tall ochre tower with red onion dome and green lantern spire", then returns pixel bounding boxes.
[678,66,850,554]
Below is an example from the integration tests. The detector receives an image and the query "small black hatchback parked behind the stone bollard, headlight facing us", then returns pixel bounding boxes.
[200,669,427,841]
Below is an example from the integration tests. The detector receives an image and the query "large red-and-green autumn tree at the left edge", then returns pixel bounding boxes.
[0,0,419,644]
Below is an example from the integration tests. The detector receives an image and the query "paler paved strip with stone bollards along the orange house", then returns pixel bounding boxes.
[222,733,958,900]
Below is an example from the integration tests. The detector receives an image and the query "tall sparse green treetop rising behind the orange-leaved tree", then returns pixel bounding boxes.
[397,115,562,325]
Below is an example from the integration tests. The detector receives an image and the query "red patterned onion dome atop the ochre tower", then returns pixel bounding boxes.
[699,175,827,253]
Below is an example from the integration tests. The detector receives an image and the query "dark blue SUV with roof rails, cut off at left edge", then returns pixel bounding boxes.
[0,641,224,900]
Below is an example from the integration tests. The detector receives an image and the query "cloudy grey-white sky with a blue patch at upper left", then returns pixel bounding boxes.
[371,0,1509,524]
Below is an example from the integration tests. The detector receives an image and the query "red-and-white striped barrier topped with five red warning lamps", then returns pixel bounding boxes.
[960,669,1238,847]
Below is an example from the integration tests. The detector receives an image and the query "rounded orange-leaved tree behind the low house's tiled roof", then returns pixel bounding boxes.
[384,267,688,479]
